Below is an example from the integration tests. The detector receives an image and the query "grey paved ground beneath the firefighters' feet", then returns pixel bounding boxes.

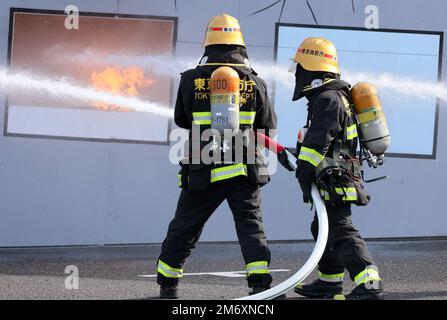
[0,240,447,300]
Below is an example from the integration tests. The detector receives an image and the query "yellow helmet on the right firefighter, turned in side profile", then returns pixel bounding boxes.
[289,38,340,74]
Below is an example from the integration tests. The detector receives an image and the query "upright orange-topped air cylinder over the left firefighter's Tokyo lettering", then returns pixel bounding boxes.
[210,66,240,133]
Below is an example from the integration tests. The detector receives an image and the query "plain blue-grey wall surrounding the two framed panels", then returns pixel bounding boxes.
[0,0,447,246]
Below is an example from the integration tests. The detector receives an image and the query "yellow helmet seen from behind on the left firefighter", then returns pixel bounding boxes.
[203,13,245,47]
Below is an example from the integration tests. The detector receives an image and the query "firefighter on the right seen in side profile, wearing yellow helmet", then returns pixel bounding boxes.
[280,38,383,299]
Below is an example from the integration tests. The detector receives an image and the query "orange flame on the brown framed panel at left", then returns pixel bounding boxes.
[90,66,155,111]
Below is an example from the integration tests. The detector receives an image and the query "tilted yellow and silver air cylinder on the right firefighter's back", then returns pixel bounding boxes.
[351,82,391,155]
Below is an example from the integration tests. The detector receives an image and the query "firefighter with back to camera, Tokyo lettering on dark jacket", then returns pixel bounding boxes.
[157,14,276,298]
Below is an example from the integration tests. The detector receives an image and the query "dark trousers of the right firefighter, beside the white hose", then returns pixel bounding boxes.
[311,204,374,281]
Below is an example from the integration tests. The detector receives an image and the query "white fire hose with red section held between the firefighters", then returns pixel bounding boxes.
[237,133,329,300]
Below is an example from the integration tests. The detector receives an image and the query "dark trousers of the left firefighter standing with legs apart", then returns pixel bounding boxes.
[159,176,271,282]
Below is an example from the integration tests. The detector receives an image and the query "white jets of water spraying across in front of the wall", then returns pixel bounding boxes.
[0,52,447,117]
